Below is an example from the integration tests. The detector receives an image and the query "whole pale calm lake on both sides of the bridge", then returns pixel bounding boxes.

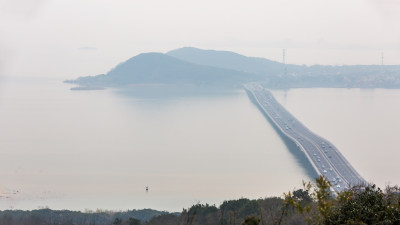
[0,78,400,211]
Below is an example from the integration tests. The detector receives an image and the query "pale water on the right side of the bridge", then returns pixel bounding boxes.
[273,88,400,187]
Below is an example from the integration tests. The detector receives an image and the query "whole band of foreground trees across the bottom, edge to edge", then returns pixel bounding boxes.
[0,177,400,225]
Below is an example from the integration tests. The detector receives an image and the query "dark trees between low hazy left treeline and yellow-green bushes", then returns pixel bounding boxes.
[144,197,302,225]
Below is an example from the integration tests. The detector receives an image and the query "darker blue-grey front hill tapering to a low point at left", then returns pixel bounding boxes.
[66,53,262,87]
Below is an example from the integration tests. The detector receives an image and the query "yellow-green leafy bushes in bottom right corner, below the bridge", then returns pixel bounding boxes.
[284,176,400,225]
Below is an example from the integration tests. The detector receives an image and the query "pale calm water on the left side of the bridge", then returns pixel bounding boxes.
[0,79,308,211]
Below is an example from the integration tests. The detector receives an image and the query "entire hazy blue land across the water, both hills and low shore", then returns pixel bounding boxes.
[65,47,400,90]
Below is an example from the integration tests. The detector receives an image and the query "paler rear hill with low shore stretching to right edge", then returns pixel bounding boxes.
[167,47,400,88]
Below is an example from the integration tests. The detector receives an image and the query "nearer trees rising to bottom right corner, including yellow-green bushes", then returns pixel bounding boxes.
[149,176,400,225]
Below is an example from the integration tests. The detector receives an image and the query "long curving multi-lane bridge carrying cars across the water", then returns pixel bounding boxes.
[244,83,366,192]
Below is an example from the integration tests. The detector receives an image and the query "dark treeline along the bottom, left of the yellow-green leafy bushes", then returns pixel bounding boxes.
[0,197,293,225]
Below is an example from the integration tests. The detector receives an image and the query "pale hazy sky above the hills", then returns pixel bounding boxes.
[0,0,400,78]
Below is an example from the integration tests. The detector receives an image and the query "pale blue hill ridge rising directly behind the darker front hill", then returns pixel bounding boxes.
[166,47,292,76]
